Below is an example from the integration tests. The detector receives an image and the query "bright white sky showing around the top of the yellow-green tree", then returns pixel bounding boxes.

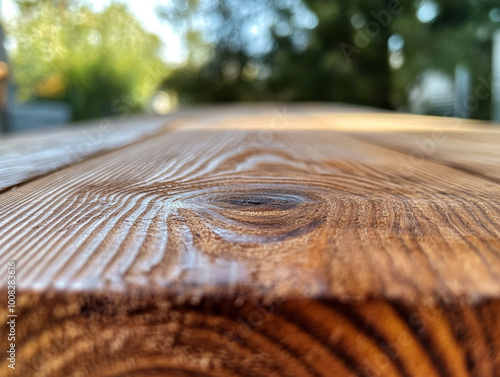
[0,0,186,65]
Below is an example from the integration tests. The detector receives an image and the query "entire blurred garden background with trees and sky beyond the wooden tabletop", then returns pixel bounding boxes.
[0,0,500,132]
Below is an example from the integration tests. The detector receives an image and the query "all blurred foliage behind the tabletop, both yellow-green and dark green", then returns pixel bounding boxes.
[8,0,500,119]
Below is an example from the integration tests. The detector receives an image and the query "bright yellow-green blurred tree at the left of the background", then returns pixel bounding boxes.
[8,0,168,120]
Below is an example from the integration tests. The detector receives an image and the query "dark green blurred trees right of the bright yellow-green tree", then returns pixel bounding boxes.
[160,0,500,119]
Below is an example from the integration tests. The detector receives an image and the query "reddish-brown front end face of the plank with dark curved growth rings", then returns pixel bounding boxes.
[2,292,500,377]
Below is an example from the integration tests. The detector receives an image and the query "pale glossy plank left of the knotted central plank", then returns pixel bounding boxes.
[0,116,173,190]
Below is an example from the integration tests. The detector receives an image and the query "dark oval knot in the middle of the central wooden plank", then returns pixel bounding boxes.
[174,183,328,258]
